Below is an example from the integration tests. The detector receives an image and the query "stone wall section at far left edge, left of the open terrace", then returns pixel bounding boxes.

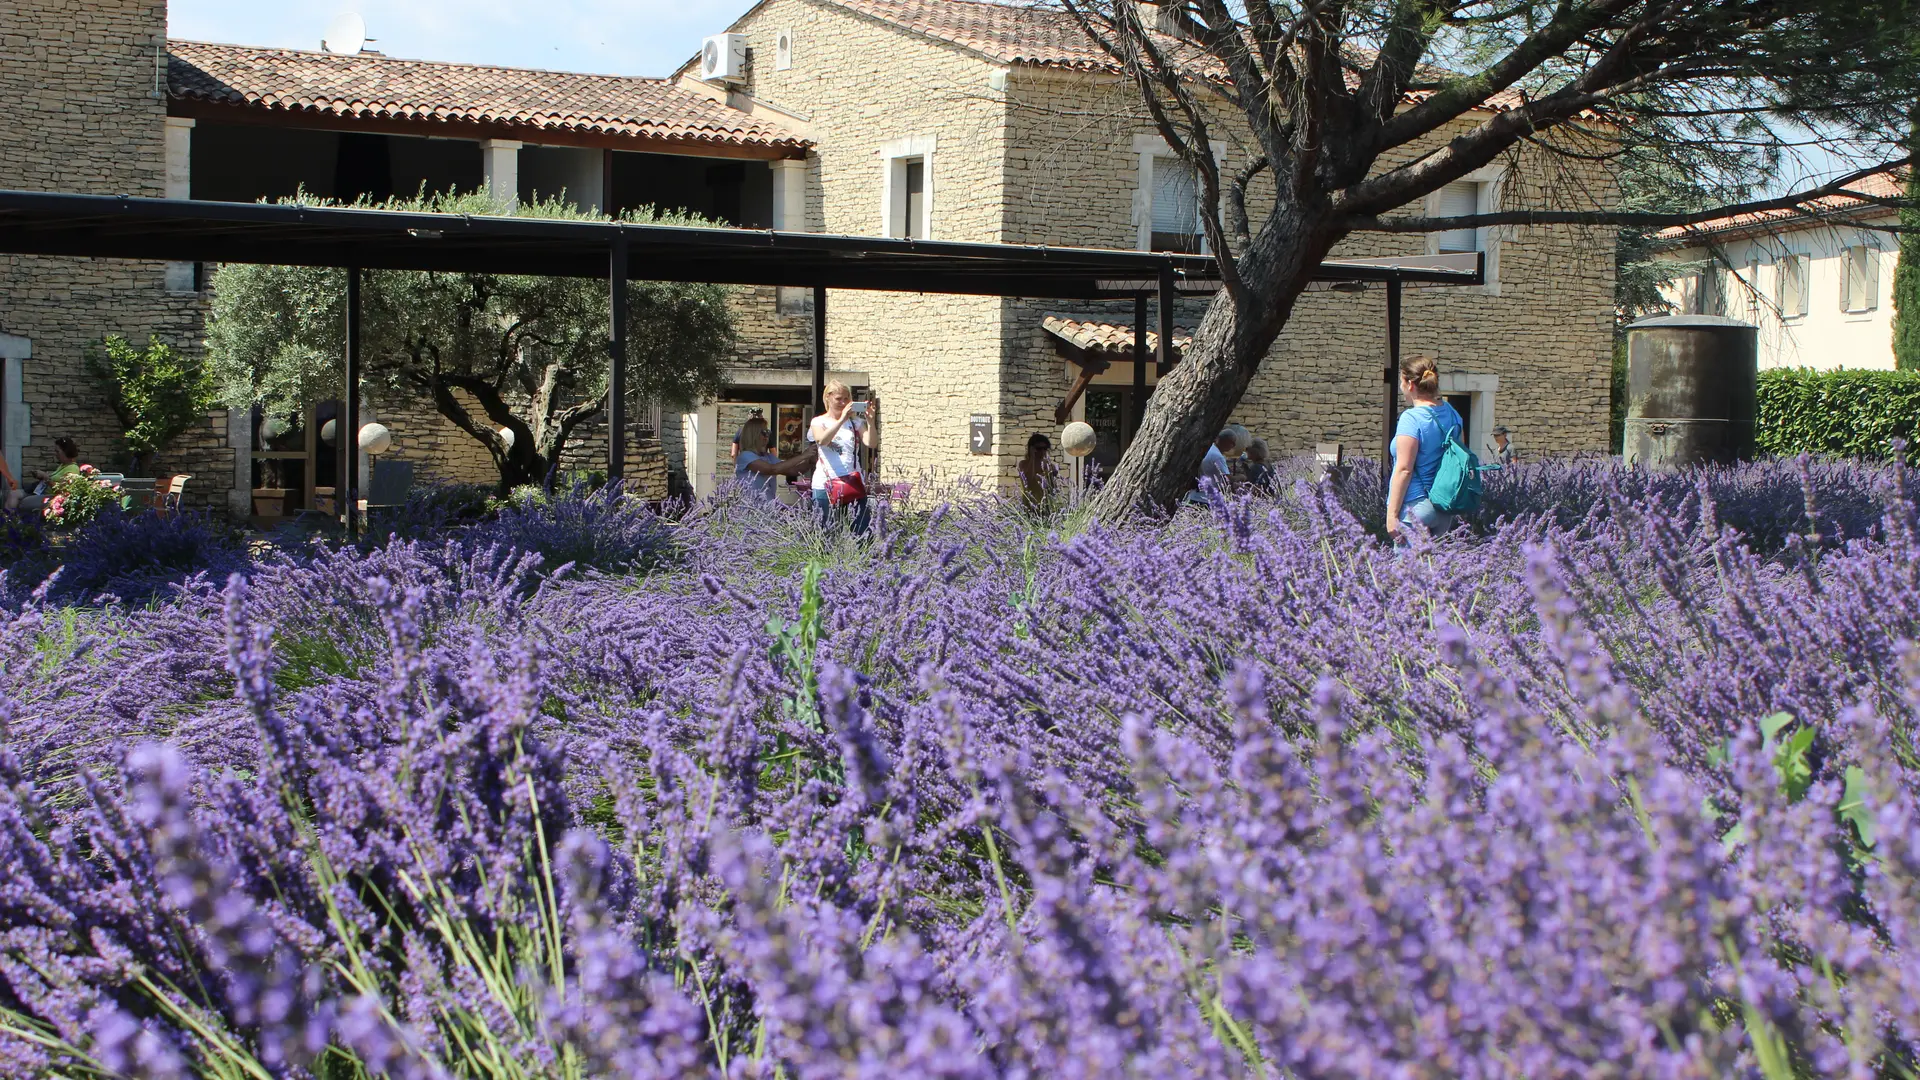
[0,0,232,505]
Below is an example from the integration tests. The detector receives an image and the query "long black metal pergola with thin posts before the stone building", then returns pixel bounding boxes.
[0,190,1484,525]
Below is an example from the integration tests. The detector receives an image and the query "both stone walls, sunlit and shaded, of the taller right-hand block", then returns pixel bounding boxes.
[695,0,1615,488]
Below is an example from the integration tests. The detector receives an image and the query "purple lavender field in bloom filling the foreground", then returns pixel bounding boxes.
[0,461,1920,1080]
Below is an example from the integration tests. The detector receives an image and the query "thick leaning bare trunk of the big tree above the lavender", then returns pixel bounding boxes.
[1092,208,1336,521]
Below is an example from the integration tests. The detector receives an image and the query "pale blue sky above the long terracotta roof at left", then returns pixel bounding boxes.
[167,0,737,75]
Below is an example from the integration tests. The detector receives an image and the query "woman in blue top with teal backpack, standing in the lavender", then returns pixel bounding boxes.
[1386,356,1480,544]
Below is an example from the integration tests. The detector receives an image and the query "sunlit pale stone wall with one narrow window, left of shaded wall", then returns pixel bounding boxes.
[722,0,1018,482]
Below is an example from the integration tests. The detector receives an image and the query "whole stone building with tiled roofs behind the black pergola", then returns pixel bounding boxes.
[0,0,1613,511]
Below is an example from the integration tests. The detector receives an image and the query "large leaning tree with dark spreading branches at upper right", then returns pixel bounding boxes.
[1050,0,1920,515]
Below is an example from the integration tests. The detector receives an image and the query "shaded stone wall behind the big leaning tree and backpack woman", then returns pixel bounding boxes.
[1002,69,1617,465]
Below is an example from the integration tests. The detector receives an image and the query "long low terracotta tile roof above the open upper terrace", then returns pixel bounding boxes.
[167,40,808,150]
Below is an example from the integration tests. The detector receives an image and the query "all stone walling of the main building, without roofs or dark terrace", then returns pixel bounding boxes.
[0,0,1613,505]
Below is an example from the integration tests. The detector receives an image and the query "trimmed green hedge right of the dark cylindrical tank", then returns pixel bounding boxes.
[1757,367,1920,465]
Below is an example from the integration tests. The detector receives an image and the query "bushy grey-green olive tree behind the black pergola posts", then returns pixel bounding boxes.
[207,194,735,492]
